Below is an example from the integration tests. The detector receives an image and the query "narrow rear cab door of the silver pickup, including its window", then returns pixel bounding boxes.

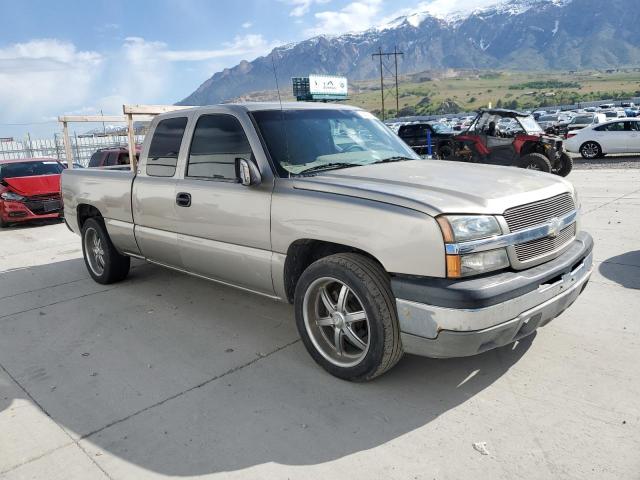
[131,114,188,268]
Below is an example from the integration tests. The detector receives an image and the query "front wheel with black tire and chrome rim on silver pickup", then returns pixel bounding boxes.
[295,253,403,381]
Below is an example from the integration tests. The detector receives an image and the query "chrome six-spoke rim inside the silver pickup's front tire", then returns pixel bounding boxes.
[302,277,370,367]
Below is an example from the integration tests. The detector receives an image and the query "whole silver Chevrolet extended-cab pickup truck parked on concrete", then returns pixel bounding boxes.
[62,103,593,380]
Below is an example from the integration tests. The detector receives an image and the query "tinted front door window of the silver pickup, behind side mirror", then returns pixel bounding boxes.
[186,114,251,182]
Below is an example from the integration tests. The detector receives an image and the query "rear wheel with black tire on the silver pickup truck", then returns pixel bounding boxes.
[82,218,131,285]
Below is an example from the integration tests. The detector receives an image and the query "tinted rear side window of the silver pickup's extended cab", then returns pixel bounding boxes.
[147,117,187,177]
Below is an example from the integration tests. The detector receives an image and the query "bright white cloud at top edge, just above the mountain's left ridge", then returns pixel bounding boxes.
[306,0,382,35]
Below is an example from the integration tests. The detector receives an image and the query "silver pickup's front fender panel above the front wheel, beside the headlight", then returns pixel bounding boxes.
[271,187,446,277]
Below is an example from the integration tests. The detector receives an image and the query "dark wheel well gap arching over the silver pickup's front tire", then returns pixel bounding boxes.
[284,239,382,303]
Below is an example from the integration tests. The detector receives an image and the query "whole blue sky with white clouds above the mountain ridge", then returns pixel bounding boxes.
[0,0,491,138]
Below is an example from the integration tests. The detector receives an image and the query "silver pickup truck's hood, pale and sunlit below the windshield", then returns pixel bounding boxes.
[293,160,573,216]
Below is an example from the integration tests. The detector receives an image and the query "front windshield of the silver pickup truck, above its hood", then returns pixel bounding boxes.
[253,109,420,177]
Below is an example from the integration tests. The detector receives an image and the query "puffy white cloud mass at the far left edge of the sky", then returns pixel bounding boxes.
[0,39,104,122]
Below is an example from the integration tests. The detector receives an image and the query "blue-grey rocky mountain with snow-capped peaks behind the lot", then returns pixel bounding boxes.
[180,0,640,105]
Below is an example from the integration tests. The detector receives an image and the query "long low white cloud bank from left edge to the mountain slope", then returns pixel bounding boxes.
[0,34,280,132]
